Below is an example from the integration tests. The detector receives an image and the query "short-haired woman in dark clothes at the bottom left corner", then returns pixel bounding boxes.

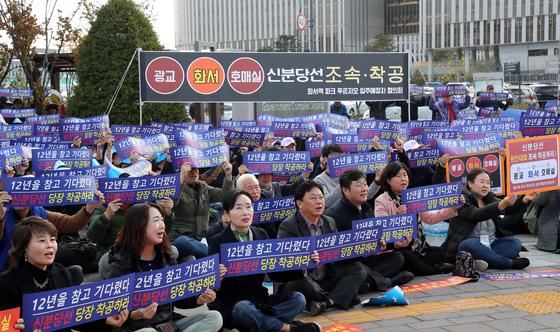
[0,216,128,332]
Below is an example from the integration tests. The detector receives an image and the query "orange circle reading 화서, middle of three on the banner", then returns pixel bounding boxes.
[187,58,225,95]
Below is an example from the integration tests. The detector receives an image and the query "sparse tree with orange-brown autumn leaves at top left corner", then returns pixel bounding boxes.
[0,0,81,113]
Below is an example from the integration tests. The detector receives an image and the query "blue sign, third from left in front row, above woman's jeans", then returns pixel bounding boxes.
[220,237,315,278]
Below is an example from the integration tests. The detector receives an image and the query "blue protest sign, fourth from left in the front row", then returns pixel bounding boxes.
[315,225,383,264]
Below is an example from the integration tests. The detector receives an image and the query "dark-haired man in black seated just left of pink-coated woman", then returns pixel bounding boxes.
[325,169,414,293]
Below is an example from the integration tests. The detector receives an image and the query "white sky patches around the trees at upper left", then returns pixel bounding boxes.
[9,0,175,49]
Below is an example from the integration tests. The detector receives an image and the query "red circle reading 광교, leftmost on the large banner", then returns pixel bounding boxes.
[146,56,185,95]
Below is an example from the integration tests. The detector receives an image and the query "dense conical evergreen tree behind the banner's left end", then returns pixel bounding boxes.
[68,0,186,124]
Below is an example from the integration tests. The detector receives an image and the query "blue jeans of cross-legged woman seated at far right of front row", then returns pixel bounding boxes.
[459,236,521,269]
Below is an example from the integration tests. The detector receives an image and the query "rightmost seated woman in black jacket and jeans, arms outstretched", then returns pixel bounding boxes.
[441,168,539,270]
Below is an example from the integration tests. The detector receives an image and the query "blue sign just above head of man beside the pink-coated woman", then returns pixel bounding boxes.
[328,151,388,179]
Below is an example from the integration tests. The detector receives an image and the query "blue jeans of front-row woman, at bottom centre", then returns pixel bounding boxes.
[231,292,305,332]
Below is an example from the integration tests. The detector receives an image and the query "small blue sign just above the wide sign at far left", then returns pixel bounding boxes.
[32,149,92,171]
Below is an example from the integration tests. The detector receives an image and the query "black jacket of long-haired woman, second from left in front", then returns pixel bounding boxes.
[108,247,199,332]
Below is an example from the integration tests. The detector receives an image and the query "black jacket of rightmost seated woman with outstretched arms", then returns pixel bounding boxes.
[441,184,527,259]
